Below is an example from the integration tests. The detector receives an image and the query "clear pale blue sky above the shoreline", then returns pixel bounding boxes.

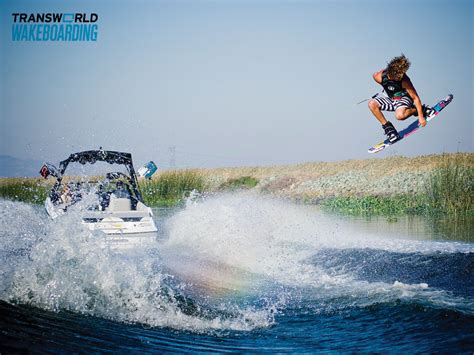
[0,0,474,168]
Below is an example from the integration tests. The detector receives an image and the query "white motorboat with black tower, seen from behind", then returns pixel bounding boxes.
[40,150,158,251]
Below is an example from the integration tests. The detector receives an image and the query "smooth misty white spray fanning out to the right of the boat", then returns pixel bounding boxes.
[162,193,474,309]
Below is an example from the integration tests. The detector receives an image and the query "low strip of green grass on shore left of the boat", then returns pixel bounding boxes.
[0,178,51,204]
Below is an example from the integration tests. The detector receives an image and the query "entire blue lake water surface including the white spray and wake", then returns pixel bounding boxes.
[0,193,474,353]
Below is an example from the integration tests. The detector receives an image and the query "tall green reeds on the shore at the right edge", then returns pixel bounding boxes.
[426,154,474,217]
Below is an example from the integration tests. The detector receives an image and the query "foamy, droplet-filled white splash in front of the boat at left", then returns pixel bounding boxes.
[0,201,274,332]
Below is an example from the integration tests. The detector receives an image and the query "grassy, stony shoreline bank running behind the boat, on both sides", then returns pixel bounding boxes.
[0,153,474,218]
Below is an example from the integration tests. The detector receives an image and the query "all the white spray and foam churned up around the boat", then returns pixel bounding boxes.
[0,193,474,331]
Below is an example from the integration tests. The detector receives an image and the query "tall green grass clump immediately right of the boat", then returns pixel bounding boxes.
[139,170,207,206]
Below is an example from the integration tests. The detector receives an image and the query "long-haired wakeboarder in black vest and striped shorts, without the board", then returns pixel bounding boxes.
[369,54,432,143]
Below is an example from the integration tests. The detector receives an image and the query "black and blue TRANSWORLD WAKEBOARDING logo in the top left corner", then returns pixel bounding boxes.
[12,13,99,42]
